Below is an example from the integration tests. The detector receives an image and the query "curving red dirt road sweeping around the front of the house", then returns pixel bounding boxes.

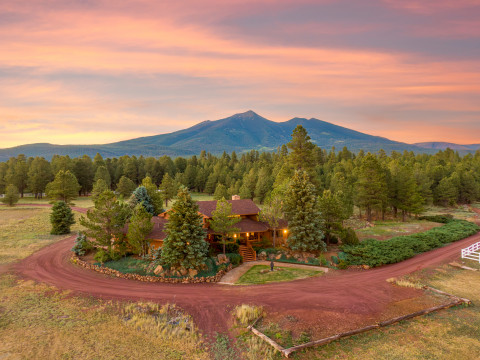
[12,209,480,333]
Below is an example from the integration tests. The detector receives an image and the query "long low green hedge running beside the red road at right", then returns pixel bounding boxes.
[342,219,480,267]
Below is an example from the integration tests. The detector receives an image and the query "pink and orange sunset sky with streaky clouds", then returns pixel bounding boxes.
[0,0,480,148]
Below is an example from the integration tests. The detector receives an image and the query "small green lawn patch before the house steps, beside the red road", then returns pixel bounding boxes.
[237,265,323,285]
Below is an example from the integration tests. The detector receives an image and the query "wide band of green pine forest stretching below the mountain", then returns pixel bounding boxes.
[0,126,480,220]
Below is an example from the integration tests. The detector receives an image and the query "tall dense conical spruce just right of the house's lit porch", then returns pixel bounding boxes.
[285,170,326,251]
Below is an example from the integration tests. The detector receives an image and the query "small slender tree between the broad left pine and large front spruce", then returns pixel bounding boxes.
[127,204,153,256]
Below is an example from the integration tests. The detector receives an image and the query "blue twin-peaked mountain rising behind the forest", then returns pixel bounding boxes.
[0,111,454,161]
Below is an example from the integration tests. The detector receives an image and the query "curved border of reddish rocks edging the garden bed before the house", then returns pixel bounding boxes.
[70,252,232,284]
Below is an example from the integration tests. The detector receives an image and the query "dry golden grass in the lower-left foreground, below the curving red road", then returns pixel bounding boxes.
[0,275,210,360]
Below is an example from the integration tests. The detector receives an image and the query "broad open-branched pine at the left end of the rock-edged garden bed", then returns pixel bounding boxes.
[80,190,130,255]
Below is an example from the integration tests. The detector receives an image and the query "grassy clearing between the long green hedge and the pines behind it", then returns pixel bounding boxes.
[356,220,443,240]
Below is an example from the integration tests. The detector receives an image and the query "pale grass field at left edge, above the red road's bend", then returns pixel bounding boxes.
[0,206,81,265]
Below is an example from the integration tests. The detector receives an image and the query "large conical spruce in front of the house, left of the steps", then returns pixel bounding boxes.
[161,186,208,269]
